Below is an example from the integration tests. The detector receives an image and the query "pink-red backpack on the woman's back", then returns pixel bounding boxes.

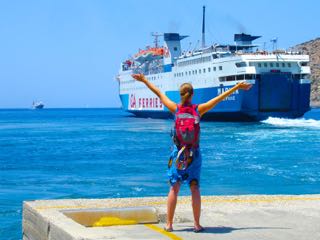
[175,104,200,148]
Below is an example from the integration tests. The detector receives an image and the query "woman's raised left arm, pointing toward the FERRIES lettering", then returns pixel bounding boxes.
[132,74,177,113]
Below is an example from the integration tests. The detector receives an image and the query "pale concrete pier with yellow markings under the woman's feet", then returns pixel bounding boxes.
[23,194,320,240]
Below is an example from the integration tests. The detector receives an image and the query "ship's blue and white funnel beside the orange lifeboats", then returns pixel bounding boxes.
[163,33,188,72]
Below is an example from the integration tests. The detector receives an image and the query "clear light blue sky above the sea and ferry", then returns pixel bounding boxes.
[0,0,320,108]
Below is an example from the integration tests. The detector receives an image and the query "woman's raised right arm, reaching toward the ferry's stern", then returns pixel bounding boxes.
[198,82,252,116]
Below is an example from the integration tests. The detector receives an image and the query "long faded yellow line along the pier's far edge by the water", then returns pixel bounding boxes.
[35,196,320,210]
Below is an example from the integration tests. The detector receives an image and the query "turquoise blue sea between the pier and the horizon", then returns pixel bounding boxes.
[0,109,320,240]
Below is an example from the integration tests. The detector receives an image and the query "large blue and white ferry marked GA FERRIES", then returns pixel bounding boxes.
[116,9,311,121]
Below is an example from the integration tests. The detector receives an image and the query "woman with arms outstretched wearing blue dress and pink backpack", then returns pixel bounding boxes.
[132,74,251,232]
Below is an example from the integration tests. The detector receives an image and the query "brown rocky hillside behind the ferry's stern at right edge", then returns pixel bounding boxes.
[294,38,320,106]
